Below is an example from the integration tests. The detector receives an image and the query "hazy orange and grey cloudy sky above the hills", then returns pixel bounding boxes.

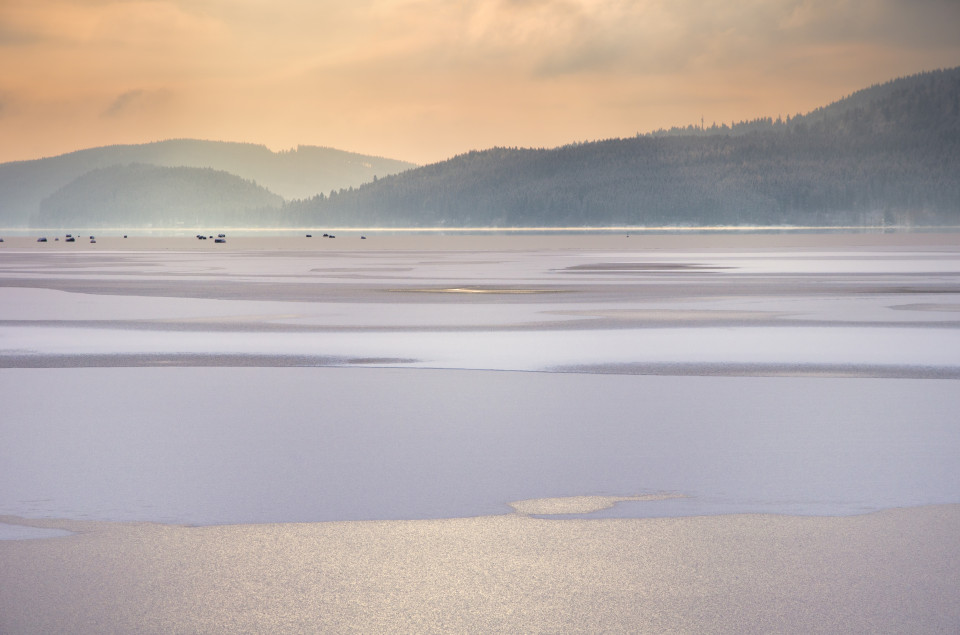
[0,0,960,163]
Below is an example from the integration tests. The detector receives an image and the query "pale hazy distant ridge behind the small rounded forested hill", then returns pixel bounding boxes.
[0,139,415,227]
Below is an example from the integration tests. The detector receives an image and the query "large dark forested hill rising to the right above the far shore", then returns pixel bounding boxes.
[284,68,960,227]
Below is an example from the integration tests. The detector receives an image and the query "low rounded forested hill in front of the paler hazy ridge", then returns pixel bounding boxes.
[35,163,283,229]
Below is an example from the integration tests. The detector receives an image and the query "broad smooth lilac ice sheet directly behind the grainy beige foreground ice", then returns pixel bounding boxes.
[0,368,960,524]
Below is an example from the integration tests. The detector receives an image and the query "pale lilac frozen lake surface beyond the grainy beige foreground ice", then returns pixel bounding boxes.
[0,231,960,525]
